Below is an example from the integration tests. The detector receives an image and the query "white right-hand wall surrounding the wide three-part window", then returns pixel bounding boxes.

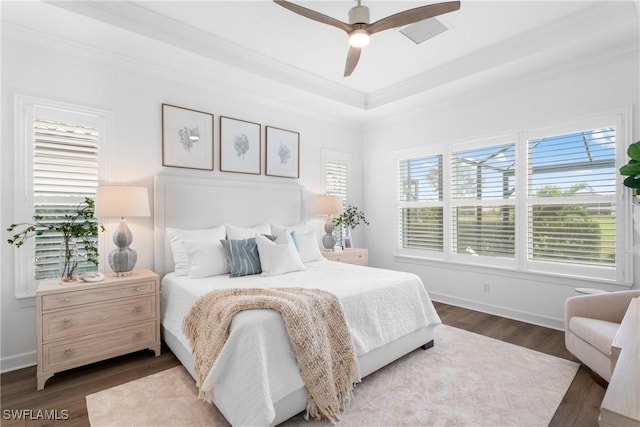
[364,50,640,328]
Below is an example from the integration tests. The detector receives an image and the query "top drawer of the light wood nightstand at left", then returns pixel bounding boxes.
[42,280,155,311]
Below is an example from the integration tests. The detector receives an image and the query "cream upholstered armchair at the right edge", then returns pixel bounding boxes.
[564,289,640,382]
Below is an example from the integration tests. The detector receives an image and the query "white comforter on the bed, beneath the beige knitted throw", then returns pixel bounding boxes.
[161,261,440,426]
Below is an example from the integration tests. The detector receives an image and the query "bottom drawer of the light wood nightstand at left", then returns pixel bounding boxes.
[43,320,156,370]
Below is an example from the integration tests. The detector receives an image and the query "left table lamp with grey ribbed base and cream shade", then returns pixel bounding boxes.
[96,185,151,276]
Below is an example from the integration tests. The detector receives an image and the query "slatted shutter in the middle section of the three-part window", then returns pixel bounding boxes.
[451,143,515,258]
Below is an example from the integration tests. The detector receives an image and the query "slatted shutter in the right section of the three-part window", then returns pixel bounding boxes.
[528,126,617,266]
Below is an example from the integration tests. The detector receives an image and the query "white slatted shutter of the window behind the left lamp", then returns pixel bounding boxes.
[33,117,100,280]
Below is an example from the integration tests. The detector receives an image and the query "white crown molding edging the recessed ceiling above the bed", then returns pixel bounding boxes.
[40,0,639,112]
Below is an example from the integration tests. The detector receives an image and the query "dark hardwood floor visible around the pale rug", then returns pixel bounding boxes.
[0,303,605,427]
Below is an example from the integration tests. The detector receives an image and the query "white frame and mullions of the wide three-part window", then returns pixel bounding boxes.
[394,106,633,287]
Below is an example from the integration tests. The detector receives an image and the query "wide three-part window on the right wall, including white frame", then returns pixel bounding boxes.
[397,112,632,284]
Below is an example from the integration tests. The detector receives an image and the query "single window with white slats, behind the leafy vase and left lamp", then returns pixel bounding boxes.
[15,96,106,297]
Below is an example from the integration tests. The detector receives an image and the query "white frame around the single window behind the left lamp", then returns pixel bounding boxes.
[12,94,111,300]
